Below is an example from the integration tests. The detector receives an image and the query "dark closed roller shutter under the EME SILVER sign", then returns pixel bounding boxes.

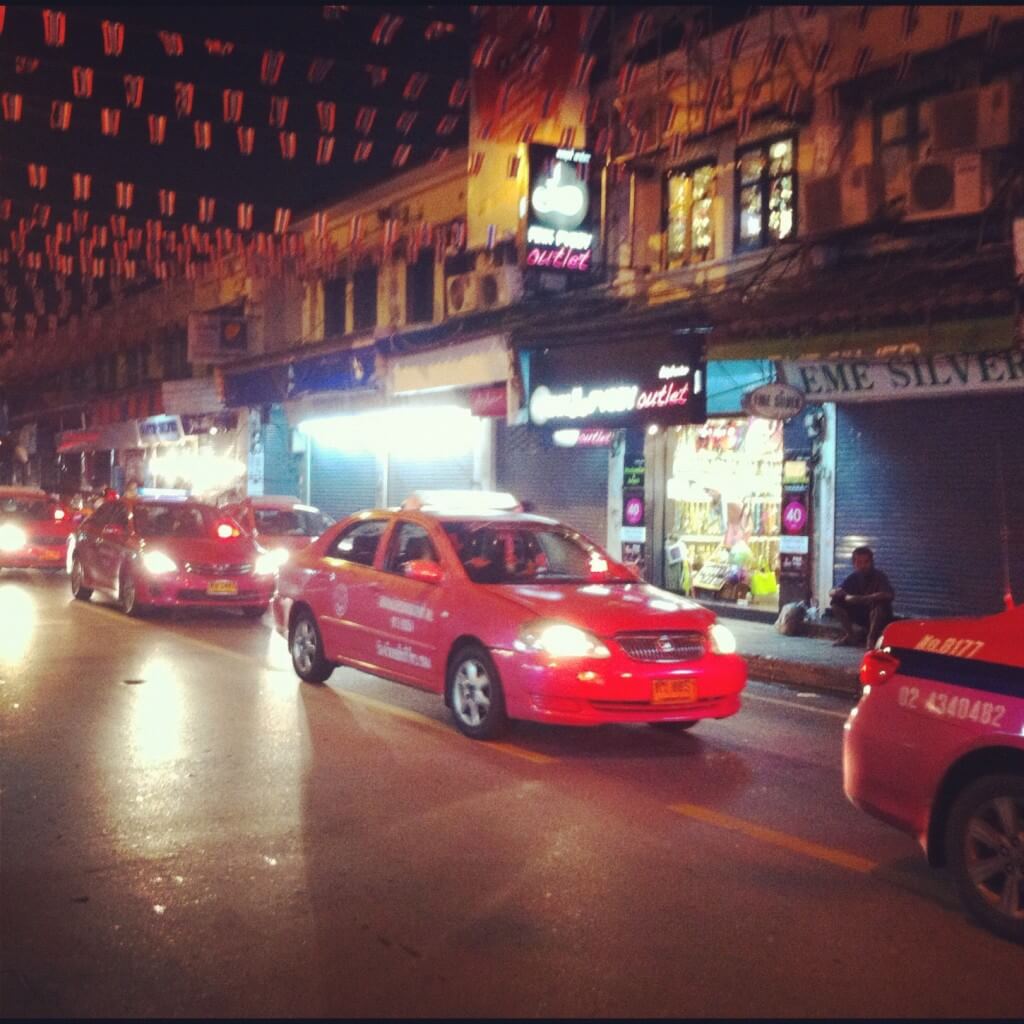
[835,395,1024,616]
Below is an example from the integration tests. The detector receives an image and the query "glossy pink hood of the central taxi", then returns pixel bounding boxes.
[488,583,715,637]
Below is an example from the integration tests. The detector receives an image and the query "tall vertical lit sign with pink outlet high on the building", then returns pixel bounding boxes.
[526,145,595,271]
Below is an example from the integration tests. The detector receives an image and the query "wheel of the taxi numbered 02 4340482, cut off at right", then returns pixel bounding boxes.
[946,775,1024,942]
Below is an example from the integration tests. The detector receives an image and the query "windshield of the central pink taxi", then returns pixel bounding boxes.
[443,520,622,584]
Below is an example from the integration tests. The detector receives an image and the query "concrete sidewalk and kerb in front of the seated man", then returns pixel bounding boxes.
[716,609,864,696]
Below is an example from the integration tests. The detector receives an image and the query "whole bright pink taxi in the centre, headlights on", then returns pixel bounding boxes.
[273,493,746,739]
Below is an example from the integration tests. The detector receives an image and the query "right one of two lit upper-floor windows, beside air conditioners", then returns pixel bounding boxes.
[736,138,797,249]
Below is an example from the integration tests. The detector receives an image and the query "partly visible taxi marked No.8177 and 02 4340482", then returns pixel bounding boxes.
[843,606,1024,941]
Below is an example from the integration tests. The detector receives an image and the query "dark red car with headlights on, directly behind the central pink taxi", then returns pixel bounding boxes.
[71,498,274,617]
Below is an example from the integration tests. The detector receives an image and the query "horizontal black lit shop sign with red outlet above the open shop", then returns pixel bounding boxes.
[523,338,707,429]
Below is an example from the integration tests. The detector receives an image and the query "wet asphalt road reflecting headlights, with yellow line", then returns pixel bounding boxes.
[0,572,1024,1017]
